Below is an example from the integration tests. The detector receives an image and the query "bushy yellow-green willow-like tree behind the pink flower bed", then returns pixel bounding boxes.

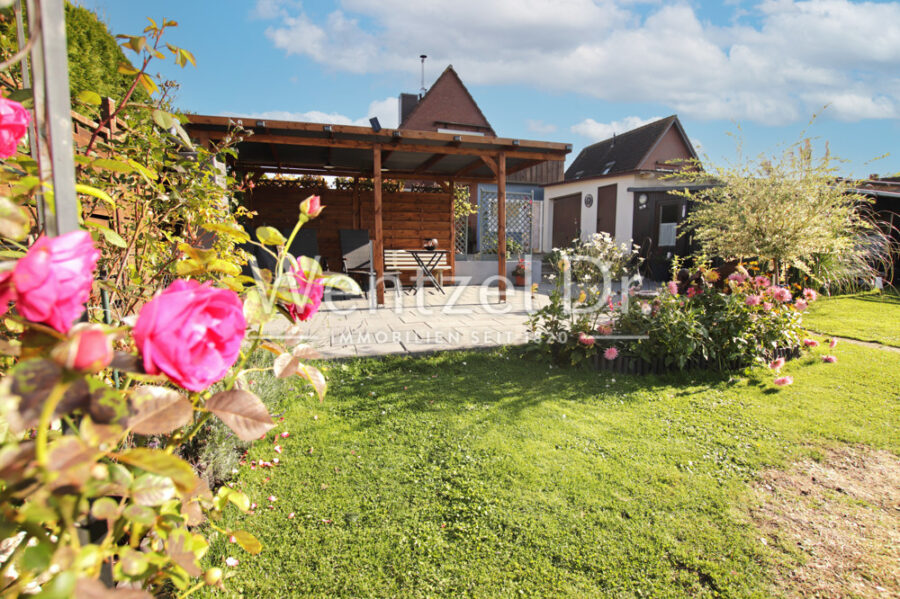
[674,139,885,285]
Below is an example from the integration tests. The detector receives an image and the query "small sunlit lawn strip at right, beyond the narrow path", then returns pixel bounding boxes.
[803,292,900,347]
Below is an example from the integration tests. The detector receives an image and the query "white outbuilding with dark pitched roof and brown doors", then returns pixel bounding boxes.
[543,115,697,268]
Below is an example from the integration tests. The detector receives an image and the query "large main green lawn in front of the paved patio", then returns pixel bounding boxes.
[205,344,900,598]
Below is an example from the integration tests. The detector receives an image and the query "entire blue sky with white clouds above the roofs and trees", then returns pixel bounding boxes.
[81,0,900,177]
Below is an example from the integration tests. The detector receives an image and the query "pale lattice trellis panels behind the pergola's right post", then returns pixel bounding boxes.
[478,189,535,254]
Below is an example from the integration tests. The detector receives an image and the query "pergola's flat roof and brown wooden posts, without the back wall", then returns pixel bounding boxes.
[186,115,572,304]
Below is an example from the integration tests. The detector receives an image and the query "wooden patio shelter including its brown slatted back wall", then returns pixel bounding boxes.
[186,115,571,304]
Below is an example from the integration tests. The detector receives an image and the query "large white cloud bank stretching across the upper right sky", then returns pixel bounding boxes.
[257,0,900,124]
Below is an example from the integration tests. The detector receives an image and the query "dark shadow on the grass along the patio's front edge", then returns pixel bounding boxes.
[335,350,729,430]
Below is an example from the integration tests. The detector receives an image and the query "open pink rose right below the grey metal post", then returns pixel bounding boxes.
[13,231,100,333]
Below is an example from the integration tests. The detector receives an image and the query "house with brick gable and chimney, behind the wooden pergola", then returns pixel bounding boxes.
[398,65,563,256]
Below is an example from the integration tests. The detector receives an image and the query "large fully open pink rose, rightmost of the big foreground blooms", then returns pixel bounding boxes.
[134,279,247,391]
